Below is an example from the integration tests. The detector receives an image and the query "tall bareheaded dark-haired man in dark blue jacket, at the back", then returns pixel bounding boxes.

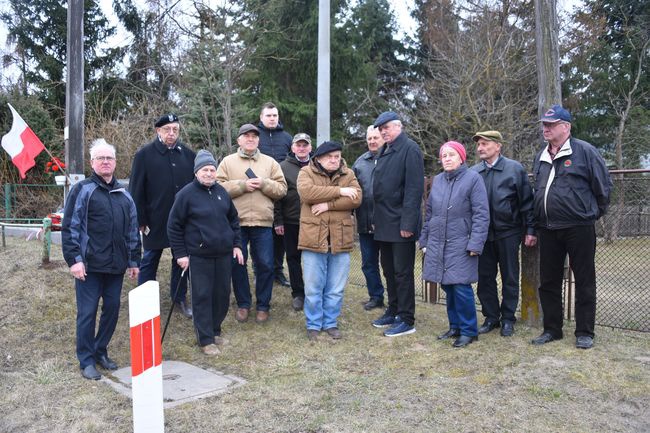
[257,102,292,287]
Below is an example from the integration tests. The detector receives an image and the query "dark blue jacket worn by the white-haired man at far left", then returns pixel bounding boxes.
[61,173,141,274]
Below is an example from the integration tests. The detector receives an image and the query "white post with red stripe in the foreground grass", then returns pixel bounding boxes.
[129,281,165,433]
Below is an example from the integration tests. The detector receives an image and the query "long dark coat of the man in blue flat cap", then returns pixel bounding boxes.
[372,132,424,242]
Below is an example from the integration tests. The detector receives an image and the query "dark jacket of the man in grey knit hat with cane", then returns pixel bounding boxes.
[167,179,241,259]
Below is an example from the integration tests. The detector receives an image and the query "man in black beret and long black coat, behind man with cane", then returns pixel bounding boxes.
[129,113,195,318]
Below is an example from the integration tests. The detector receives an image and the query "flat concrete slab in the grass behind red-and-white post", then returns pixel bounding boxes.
[102,361,246,409]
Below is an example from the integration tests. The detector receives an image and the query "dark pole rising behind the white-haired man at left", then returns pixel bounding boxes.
[63,0,84,203]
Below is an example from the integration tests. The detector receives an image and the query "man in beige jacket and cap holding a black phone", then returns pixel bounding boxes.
[217,124,287,323]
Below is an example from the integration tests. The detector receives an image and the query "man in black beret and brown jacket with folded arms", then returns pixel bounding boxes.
[298,141,361,341]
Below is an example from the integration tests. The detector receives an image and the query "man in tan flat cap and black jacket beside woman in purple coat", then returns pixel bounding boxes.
[472,131,537,337]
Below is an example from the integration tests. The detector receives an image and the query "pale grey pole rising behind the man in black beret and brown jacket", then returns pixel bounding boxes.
[316,0,330,146]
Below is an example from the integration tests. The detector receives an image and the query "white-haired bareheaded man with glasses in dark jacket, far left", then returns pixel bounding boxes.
[61,139,140,380]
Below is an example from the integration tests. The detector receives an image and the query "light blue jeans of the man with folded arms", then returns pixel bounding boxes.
[302,251,350,331]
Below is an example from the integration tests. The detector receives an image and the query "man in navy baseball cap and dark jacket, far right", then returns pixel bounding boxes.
[532,105,612,349]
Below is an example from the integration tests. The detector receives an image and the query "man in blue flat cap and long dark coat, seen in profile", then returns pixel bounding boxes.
[372,111,424,337]
